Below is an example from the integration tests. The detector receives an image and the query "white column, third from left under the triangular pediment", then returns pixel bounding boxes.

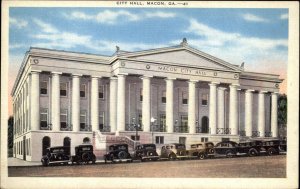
[166,78,175,133]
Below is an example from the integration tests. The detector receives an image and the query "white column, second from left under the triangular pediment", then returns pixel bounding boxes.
[142,76,152,132]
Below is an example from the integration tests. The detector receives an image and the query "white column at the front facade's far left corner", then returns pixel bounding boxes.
[30,71,41,131]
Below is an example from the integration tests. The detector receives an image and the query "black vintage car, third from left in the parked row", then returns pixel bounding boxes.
[104,144,132,163]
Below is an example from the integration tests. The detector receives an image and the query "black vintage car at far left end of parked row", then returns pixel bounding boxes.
[41,146,70,166]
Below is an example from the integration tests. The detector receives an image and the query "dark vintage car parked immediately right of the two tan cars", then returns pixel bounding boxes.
[214,141,238,158]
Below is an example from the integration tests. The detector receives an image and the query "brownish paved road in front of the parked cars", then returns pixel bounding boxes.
[8,155,286,178]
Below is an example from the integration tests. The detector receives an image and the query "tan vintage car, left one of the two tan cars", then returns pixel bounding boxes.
[160,143,188,160]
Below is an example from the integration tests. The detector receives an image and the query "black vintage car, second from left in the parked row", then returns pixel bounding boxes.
[71,144,96,164]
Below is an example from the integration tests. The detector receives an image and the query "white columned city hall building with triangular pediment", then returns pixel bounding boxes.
[12,39,282,161]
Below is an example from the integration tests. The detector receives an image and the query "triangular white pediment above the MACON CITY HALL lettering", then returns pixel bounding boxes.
[125,49,237,70]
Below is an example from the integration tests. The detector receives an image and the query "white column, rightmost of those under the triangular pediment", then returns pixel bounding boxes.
[229,84,239,135]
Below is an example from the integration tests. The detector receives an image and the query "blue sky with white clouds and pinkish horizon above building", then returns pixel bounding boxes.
[8,7,288,115]
